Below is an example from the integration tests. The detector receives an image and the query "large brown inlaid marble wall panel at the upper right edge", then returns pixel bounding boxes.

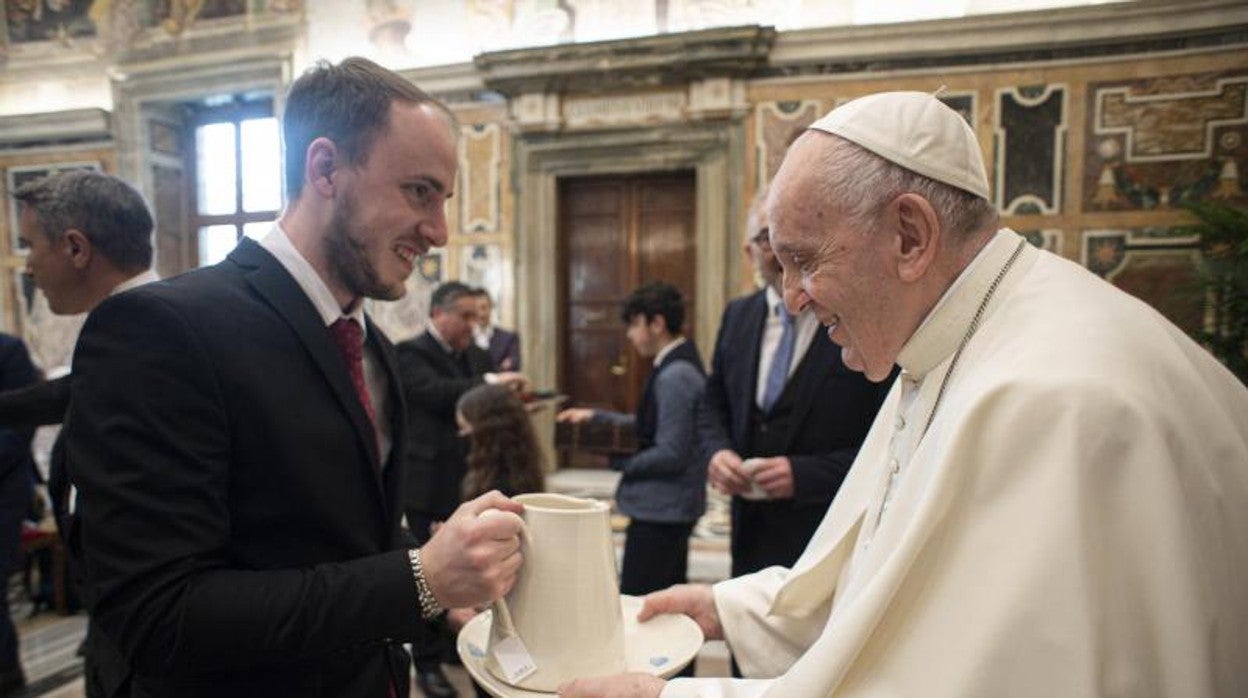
[1083,70,1248,211]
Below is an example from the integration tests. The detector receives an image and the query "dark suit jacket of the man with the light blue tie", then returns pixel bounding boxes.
[698,290,891,573]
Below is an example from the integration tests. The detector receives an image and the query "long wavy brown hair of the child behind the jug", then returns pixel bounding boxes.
[456,385,545,499]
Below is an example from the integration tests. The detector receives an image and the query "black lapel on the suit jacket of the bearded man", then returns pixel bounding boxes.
[230,238,389,489]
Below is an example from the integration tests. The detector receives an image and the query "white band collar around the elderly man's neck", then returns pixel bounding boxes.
[897,229,1020,378]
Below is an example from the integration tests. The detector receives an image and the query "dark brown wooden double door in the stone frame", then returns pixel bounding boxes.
[558,171,699,466]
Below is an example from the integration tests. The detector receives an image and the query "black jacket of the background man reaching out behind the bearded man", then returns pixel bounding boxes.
[396,332,494,521]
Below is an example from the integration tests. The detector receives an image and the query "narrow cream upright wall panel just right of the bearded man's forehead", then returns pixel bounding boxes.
[457,124,503,232]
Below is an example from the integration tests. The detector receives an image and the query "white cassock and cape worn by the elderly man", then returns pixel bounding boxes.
[663,230,1248,698]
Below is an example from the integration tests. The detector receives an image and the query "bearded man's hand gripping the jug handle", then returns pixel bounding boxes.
[421,491,524,608]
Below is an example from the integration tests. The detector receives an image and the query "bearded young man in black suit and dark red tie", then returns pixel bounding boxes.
[66,59,522,697]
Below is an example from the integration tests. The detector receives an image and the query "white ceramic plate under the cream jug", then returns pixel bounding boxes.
[456,596,703,698]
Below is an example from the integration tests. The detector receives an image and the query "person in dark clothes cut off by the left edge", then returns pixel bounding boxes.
[0,333,39,696]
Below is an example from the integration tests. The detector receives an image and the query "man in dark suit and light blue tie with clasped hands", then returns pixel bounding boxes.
[699,187,890,577]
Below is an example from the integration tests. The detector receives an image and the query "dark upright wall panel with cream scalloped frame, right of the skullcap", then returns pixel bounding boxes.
[993,85,1067,214]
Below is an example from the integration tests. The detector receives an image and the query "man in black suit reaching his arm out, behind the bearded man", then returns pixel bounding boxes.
[396,281,528,697]
